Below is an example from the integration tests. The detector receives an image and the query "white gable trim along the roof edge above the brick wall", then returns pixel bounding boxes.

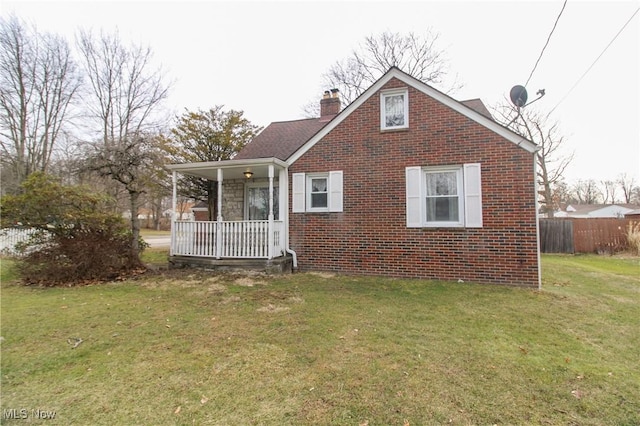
[287,67,538,164]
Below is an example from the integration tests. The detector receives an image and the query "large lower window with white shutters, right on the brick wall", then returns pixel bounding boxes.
[406,163,482,228]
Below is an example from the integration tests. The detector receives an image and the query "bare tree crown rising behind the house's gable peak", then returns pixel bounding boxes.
[303,29,460,117]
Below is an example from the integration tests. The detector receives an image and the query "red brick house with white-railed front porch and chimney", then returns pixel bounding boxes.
[168,67,540,288]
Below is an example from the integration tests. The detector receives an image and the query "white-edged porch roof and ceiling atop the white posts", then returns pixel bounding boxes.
[165,158,287,181]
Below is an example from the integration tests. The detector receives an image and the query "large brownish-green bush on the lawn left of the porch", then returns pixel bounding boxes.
[0,174,144,286]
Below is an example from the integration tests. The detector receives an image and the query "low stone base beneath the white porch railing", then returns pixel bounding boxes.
[169,255,293,274]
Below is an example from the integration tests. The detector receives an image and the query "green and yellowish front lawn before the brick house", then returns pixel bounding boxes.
[1,256,640,425]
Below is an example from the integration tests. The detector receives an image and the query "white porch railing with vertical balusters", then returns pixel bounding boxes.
[171,220,284,259]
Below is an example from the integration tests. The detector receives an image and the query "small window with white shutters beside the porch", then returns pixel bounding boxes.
[292,170,343,213]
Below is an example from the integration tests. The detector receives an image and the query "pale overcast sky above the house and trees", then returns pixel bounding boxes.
[0,0,640,184]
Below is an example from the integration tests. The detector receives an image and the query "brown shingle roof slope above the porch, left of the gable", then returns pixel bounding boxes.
[233,117,329,160]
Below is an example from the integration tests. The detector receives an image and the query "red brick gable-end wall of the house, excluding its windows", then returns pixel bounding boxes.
[289,79,538,287]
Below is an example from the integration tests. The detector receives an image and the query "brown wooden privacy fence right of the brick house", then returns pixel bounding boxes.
[540,218,638,253]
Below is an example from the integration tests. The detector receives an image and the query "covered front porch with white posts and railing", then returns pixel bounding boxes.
[167,158,293,267]
